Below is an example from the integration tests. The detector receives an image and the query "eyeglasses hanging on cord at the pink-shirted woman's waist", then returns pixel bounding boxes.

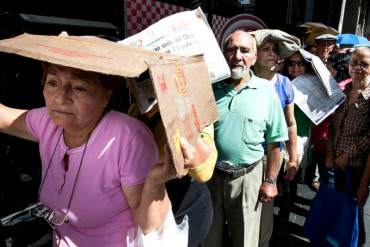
[31,203,69,229]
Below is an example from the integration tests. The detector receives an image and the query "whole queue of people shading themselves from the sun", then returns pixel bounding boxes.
[0,20,370,247]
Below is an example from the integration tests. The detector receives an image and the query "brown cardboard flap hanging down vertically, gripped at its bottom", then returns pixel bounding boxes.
[148,56,218,174]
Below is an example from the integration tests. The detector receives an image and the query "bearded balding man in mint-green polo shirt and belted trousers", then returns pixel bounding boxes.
[204,30,288,247]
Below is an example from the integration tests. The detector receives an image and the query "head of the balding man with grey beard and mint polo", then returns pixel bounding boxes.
[224,31,256,80]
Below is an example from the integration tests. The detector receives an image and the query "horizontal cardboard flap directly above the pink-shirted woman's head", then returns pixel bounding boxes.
[0,34,179,77]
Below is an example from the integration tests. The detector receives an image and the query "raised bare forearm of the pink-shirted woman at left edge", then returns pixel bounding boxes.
[0,104,37,141]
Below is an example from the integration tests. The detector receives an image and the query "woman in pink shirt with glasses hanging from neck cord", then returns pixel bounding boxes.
[0,64,201,247]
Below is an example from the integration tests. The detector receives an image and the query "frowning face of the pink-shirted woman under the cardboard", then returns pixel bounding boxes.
[43,65,111,131]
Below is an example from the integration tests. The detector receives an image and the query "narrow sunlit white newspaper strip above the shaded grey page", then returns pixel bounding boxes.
[299,49,340,96]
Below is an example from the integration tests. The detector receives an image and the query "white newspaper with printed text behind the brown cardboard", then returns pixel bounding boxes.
[118,8,230,83]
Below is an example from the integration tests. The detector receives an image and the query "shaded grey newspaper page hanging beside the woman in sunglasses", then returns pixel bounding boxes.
[292,74,346,125]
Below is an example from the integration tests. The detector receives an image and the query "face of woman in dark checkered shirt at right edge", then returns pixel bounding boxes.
[349,47,370,81]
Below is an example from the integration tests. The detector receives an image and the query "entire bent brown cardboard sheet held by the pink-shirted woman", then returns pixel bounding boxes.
[0,34,218,174]
